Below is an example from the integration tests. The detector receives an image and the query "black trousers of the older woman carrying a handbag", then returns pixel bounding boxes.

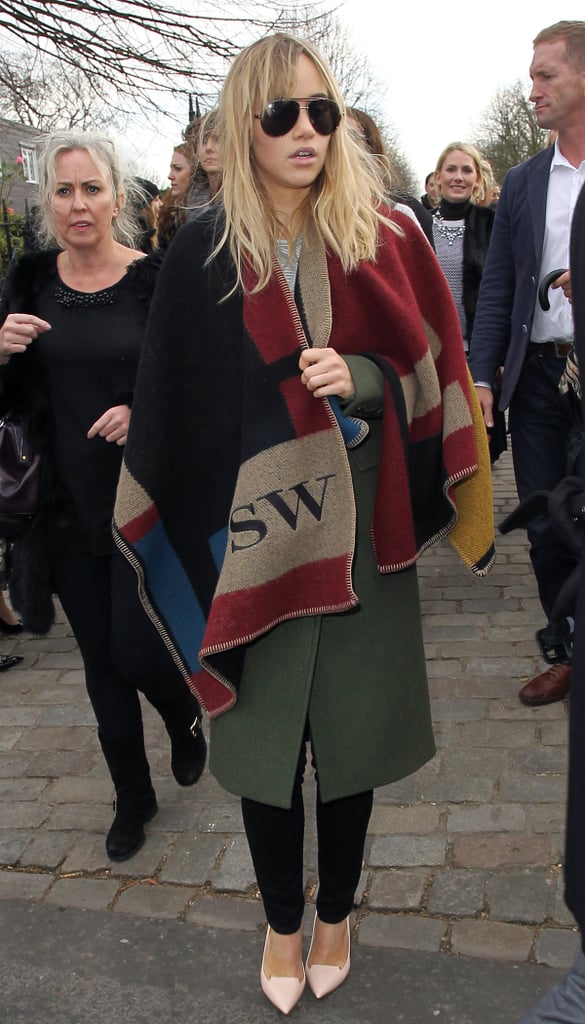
[52,551,185,739]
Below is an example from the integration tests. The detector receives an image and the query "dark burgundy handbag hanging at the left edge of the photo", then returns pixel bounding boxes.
[0,416,41,537]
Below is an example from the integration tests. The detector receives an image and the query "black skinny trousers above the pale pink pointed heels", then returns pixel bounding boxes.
[242,743,374,935]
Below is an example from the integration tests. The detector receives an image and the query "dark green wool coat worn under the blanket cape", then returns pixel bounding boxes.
[210,356,434,808]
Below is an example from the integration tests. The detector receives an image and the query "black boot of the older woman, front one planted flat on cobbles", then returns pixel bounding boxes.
[98,732,159,861]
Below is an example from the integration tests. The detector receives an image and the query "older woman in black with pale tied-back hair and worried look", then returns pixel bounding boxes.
[0,125,206,861]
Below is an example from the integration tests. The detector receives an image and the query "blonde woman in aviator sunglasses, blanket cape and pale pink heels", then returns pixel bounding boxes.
[115,34,492,1013]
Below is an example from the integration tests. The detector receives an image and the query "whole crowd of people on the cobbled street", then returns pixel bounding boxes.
[0,22,585,1024]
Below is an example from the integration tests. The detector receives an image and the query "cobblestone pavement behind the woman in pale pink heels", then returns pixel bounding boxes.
[0,455,578,968]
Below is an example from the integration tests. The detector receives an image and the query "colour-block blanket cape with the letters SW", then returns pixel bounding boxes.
[114,215,494,716]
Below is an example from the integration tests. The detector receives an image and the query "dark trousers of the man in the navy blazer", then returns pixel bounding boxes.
[509,348,576,621]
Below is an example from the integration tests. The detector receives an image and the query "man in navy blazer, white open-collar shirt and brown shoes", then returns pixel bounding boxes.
[469,22,585,705]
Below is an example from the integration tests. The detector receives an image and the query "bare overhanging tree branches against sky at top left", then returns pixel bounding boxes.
[0,0,329,105]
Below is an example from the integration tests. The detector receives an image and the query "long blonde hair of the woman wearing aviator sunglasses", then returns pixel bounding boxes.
[210,33,393,291]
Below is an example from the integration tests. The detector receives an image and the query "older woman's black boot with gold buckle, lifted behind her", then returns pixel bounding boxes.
[149,686,207,785]
